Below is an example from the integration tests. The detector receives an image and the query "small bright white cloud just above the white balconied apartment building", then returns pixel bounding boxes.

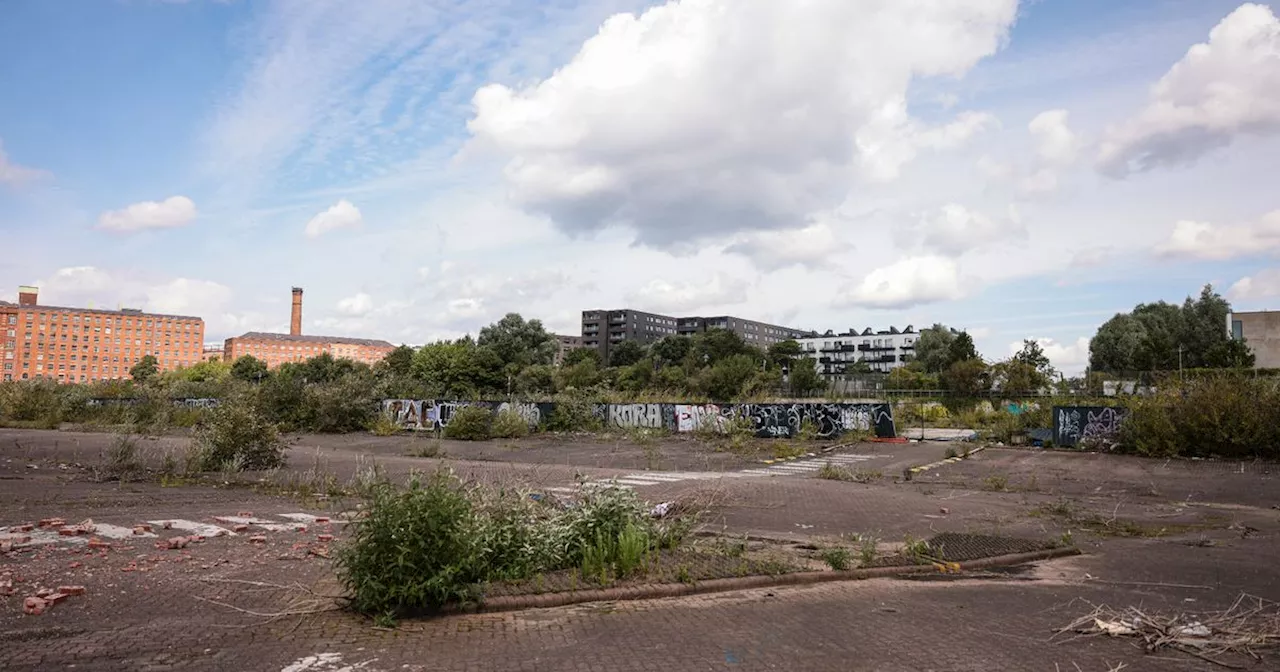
[836,256,964,308]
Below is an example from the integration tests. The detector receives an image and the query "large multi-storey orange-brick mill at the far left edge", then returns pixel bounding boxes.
[0,287,205,383]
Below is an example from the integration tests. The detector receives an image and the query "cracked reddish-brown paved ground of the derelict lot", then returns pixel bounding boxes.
[0,430,1280,672]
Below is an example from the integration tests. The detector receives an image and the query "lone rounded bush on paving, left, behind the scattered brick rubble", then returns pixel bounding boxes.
[196,399,284,471]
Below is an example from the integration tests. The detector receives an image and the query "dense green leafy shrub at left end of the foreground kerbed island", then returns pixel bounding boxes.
[337,471,483,614]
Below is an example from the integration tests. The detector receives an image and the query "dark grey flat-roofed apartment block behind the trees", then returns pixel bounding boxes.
[582,308,810,362]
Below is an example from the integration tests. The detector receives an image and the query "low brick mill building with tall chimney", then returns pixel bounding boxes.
[223,287,396,369]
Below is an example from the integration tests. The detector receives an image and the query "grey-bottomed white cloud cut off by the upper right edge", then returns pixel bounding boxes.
[1098,4,1280,177]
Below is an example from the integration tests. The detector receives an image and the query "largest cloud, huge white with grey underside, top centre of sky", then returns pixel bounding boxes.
[467,0,1016,247]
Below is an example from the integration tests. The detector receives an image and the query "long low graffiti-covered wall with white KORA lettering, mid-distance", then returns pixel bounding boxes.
[383,399,897,439]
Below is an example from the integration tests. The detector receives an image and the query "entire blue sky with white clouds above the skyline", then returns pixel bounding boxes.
[0,0,1280,375]
